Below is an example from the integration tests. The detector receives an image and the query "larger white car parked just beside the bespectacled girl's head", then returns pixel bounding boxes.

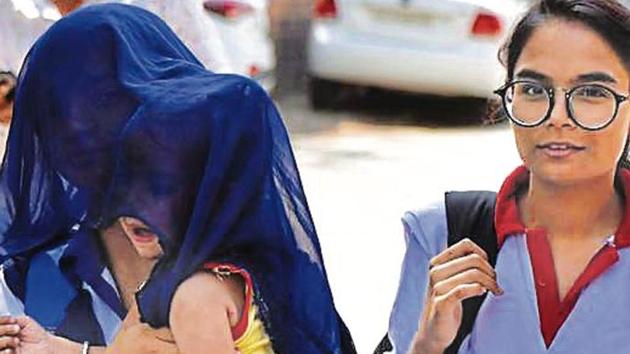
[308,0,531,108]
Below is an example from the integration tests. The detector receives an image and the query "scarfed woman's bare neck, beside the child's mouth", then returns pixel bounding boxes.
[100,223,156,309]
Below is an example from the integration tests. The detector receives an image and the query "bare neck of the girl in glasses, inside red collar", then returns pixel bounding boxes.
[518,174,624,238]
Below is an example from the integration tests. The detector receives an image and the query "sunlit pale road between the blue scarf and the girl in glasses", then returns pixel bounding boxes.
[278,95,520,353]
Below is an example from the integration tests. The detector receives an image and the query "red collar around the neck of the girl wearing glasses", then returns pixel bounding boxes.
[494,166,630,247]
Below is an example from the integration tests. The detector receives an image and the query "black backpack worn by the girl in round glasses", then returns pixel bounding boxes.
[374,191,498,354]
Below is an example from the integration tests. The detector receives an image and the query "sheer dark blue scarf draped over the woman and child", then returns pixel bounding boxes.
[0,5,356,353]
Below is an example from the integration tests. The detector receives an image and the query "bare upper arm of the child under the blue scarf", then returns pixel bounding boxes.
[170,272,245,354]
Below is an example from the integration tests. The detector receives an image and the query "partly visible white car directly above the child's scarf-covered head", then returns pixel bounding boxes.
[203,0,276,91]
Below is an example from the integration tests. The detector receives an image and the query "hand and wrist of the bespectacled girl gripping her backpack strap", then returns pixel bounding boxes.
[411,239,503,354]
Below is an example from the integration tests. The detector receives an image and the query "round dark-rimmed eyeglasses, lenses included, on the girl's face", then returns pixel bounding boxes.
[494,80,628,130]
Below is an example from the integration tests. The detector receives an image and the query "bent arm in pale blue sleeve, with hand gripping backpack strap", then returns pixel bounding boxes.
[389,206,501,354]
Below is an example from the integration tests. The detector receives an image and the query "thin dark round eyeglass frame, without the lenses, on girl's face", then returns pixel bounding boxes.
[493,80,629,131]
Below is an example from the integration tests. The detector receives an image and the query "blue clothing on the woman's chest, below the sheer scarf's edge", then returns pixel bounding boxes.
[16,230,122,345]
